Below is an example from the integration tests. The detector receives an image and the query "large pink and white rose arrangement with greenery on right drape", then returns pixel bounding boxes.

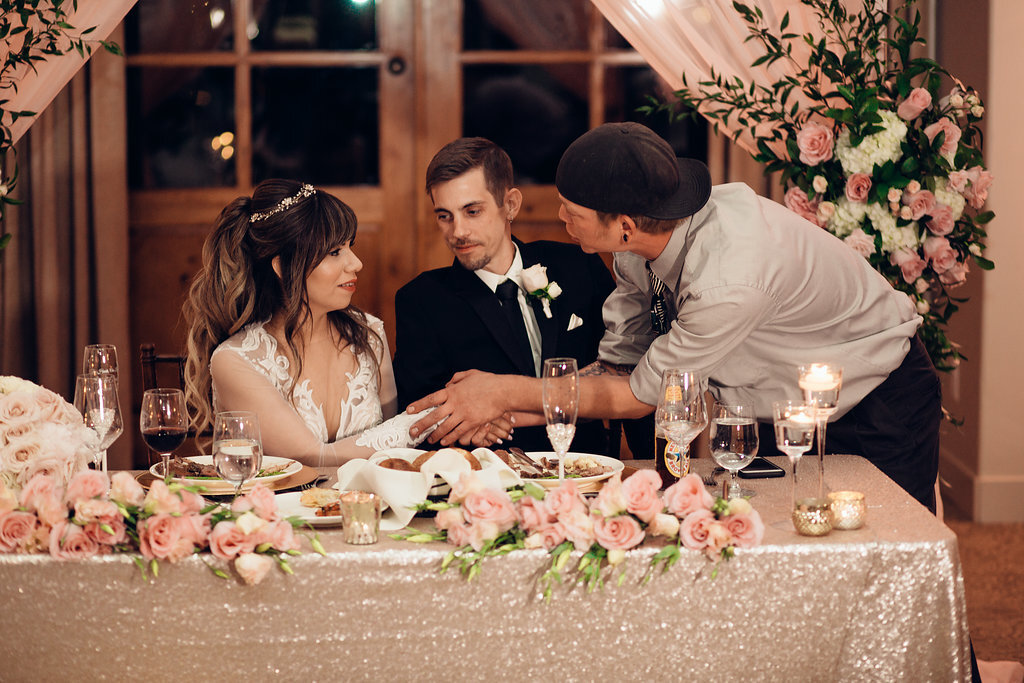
[647,0,994,371]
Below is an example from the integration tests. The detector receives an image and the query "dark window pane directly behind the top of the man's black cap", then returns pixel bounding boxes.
[604,67,708,161]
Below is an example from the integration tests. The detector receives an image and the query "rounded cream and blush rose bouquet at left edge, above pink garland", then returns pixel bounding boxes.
[0,376,97,490]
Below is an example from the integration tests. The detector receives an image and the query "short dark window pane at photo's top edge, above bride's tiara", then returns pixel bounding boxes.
[249,0,377,50]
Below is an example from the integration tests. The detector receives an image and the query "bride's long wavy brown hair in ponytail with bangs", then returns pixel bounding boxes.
[183,179,381,434]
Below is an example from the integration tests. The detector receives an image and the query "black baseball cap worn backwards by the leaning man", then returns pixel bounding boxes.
[555,122,711,220]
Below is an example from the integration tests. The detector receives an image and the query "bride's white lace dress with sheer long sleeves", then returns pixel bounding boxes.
[210,315,428,465]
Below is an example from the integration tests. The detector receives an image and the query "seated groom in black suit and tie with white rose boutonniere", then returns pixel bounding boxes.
[394,137,617,455]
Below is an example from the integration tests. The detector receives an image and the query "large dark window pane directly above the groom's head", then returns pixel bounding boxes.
[463,66,588,184]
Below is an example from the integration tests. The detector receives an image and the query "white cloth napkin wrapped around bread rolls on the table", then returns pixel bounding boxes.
[334,449,522,531]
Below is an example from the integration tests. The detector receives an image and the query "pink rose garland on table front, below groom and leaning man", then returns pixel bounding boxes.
[391,470,764,600]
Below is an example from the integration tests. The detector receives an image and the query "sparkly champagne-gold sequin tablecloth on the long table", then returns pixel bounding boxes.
[0,456,970,681]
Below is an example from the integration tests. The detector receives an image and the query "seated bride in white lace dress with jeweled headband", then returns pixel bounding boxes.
[184,180,483,467]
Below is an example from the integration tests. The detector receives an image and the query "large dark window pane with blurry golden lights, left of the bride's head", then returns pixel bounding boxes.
[127,67,234,189]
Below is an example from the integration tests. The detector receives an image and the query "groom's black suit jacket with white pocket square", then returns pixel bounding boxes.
[394,240,614,454]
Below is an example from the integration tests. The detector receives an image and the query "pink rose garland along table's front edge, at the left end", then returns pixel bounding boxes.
[0,469,324,585]
